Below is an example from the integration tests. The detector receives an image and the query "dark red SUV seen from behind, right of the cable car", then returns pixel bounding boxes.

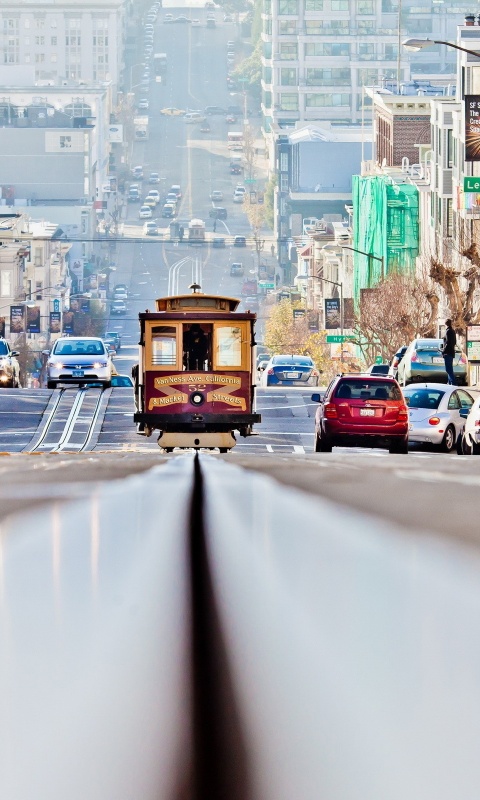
[312,374,408,453]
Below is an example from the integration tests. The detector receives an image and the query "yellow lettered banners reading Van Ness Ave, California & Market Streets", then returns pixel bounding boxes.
[148,372,246,411]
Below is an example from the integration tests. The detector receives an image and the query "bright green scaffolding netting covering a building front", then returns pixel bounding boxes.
[352,175,419,302]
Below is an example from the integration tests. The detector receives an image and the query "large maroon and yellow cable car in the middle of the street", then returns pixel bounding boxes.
[133,284,261,452]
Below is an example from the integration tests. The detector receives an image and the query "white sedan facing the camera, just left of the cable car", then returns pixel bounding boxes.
[43,336,111,389]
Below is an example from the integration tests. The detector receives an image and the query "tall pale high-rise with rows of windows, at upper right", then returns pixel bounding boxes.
[262,0,469,132]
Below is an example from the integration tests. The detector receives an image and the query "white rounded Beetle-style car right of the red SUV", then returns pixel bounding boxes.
[403,383,474,453]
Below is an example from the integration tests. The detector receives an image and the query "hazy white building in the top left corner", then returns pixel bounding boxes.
[0,0,125,87]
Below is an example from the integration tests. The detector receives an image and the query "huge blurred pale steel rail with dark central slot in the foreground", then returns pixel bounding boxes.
[0,454,480,800]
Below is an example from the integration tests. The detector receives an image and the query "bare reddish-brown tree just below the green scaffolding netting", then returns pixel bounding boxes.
[355,273,439,362]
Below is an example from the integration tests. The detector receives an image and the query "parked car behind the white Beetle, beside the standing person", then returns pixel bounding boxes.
[398,339,468,386]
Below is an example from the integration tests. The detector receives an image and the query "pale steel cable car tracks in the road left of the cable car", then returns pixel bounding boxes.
[25,387,110,453]
